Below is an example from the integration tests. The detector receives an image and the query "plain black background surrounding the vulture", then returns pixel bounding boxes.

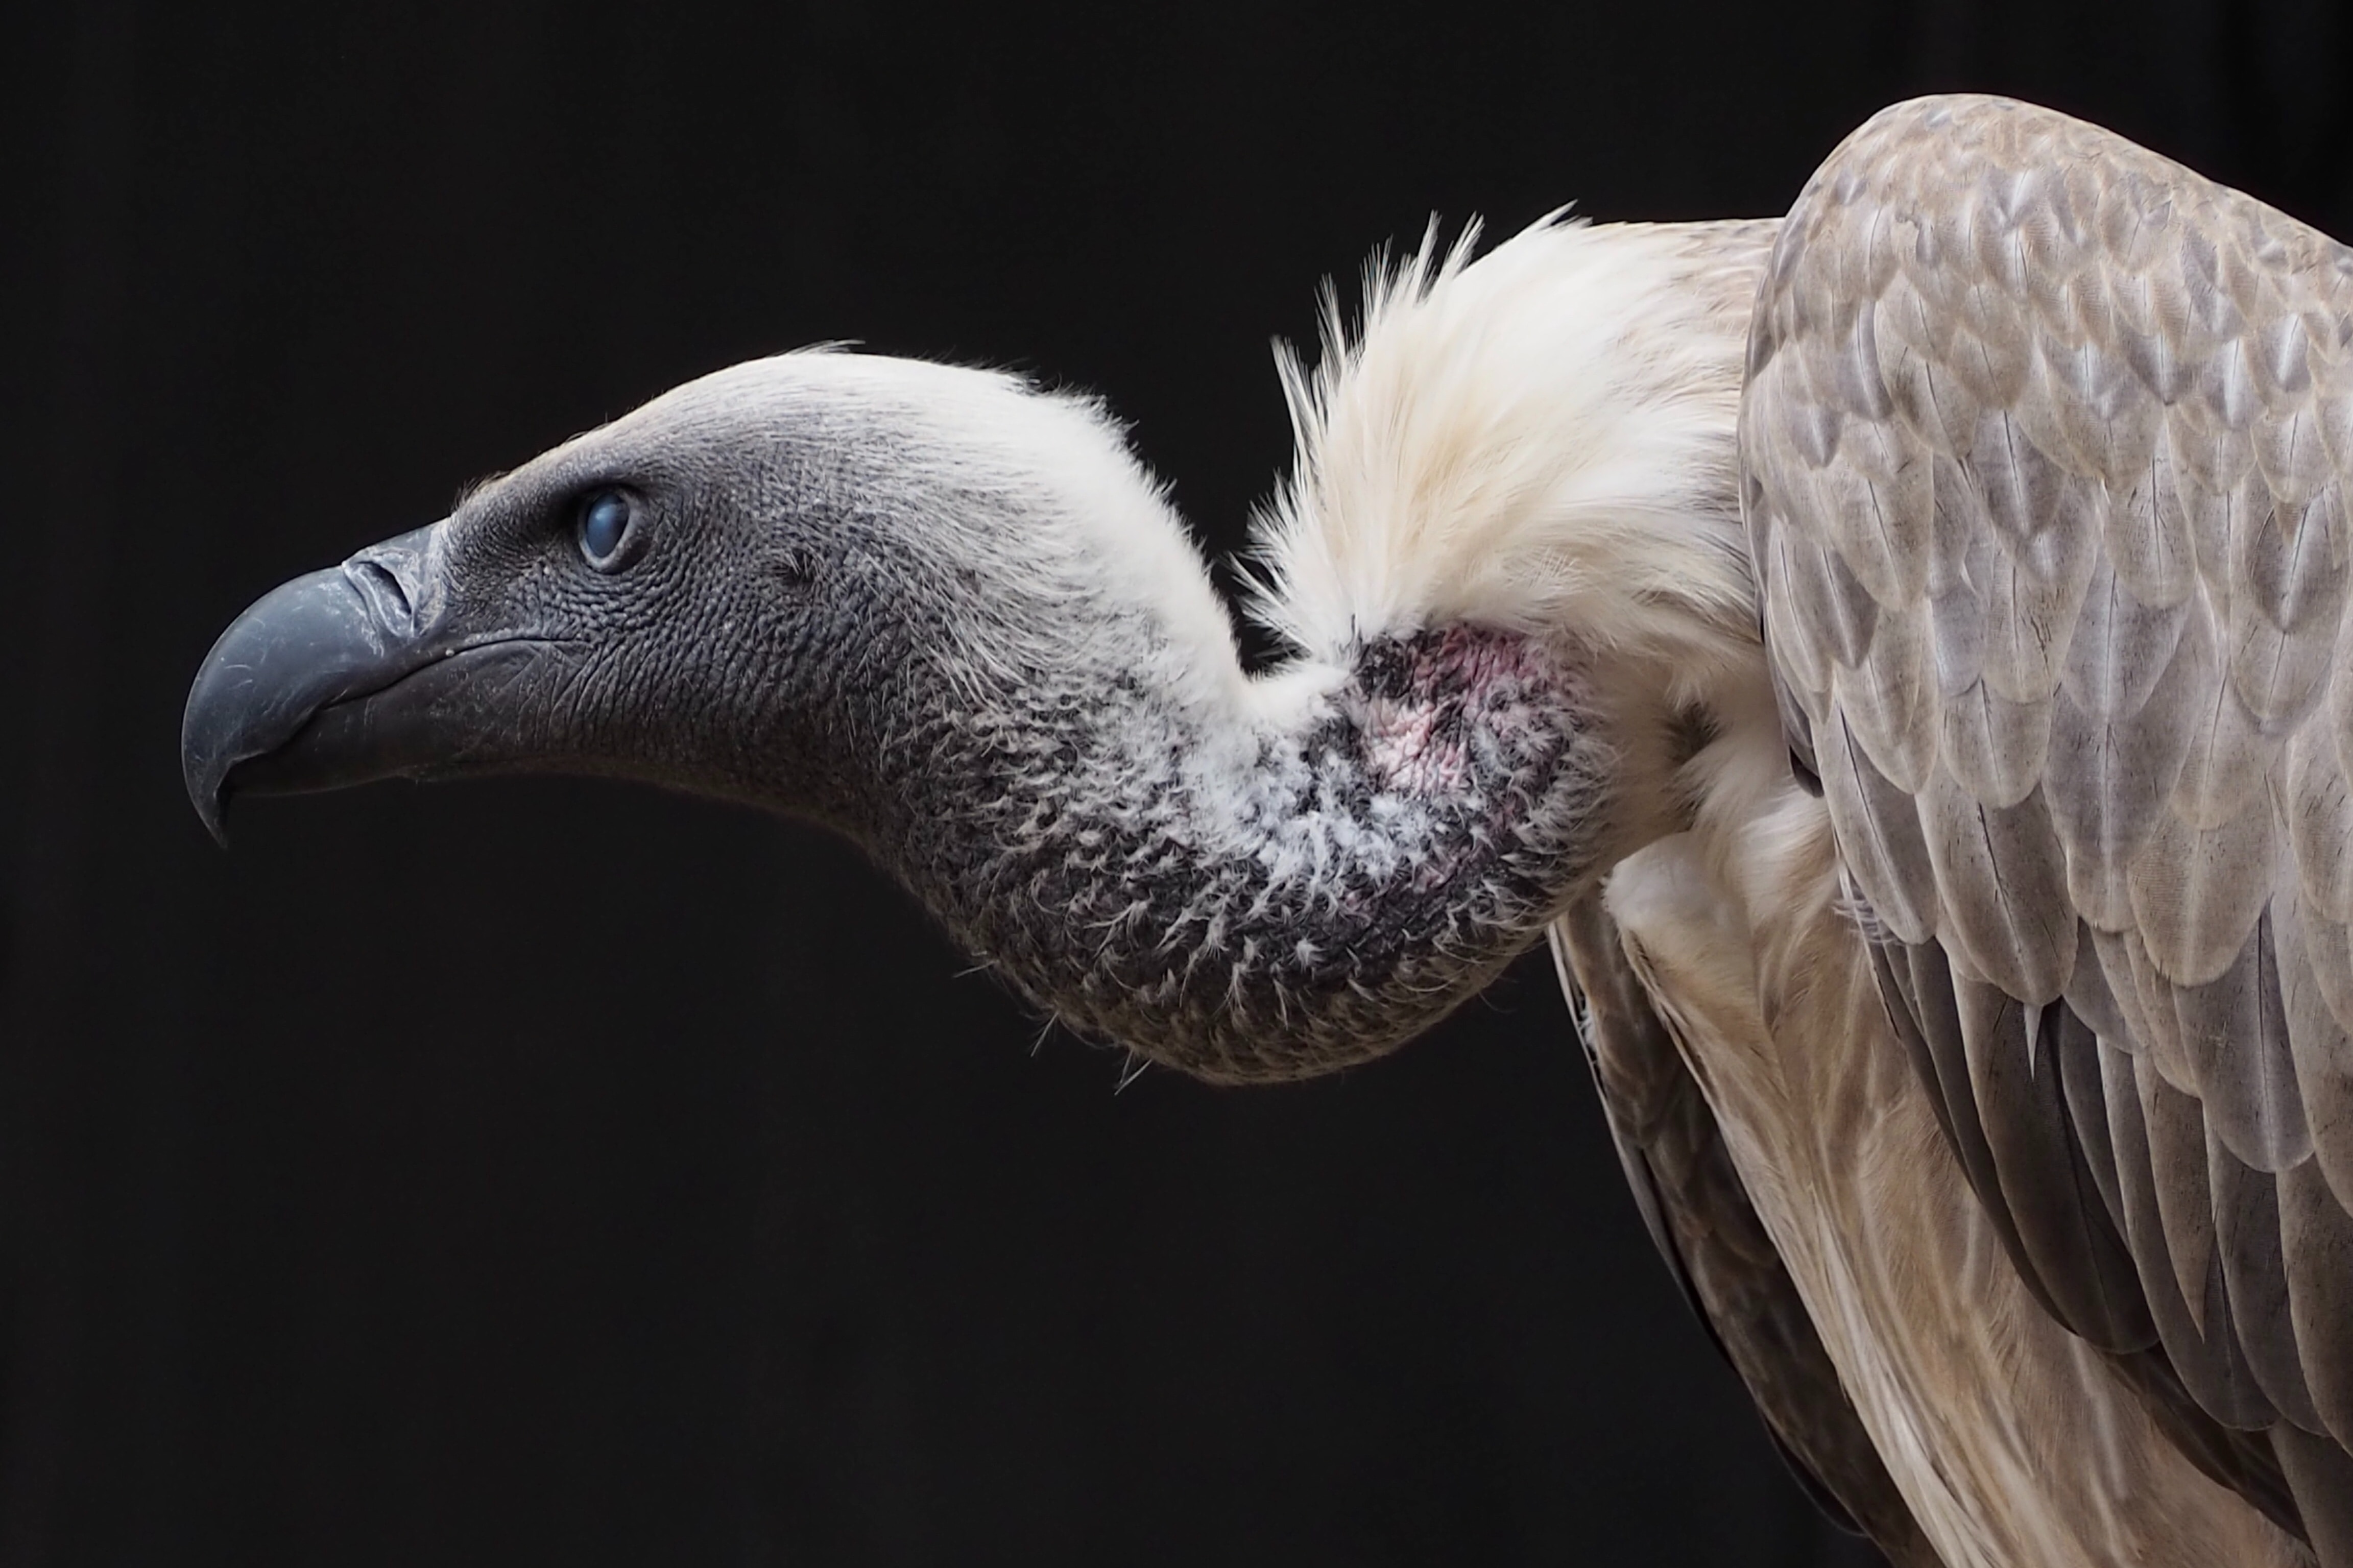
[0,0,2353,1568]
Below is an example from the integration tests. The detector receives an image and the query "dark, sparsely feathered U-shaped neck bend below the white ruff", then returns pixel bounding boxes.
[878,629,1610,1083]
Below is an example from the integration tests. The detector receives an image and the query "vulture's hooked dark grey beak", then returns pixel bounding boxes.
[179,523,562,843]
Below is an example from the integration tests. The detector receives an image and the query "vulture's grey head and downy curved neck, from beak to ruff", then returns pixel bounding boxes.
[183,355,1610,1081]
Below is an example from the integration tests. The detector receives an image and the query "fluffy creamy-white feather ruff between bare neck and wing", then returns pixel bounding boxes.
[1252,214,1772,696]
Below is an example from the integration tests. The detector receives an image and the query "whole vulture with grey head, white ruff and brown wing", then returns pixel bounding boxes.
[183,97,2353,1568]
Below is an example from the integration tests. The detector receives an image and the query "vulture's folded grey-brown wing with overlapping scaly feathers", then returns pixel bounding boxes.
[1741,97,2353,1568]
